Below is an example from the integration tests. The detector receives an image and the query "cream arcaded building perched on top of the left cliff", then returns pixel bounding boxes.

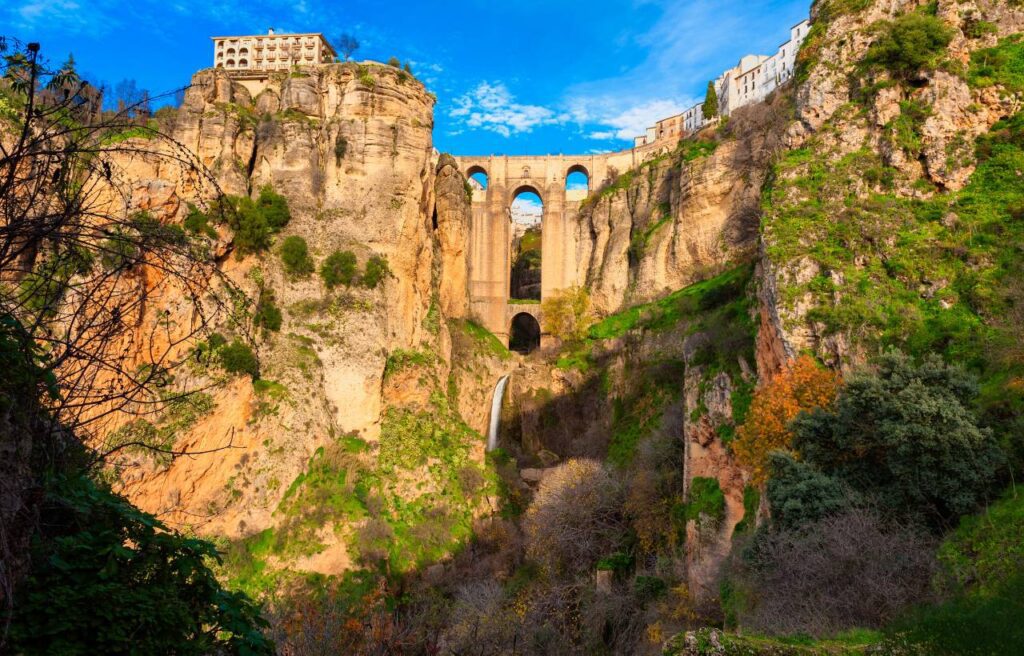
[212,30,338,71]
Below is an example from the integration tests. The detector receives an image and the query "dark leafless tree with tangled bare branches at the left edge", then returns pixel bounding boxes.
[0,38,237,630]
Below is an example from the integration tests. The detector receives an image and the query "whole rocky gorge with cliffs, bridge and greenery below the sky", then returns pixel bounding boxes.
[0,0,1024,655]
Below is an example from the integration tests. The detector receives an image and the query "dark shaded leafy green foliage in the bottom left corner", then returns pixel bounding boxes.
[10,477,273,656]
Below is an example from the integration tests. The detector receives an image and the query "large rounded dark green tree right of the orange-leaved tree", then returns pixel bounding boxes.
[792,350,1005,528]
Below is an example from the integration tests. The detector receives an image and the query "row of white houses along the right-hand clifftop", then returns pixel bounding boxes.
[634,18,811,147]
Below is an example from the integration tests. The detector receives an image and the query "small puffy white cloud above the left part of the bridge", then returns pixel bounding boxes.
[449,82,569,137]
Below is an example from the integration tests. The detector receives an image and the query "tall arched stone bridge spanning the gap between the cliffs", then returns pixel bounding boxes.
[455,144,674,344]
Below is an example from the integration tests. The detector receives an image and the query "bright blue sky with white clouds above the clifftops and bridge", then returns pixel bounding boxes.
[0,0,810,155]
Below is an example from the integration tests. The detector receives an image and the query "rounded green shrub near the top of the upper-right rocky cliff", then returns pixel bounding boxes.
[864,12,953,79]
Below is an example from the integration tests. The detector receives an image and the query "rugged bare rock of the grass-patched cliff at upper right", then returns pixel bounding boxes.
[761,0,1024,366]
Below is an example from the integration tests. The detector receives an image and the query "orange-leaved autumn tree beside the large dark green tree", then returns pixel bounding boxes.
[732,355,841,485]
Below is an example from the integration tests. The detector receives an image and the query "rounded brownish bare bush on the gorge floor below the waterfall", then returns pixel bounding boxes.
[523,460,626,573]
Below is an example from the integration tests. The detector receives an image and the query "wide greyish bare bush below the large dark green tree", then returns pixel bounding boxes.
[737,510,936,636]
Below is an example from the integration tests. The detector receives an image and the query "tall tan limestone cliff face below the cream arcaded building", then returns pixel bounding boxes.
[109,64,492,573]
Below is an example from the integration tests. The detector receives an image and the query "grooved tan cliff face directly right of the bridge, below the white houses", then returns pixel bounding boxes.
[577,96,790,313]
